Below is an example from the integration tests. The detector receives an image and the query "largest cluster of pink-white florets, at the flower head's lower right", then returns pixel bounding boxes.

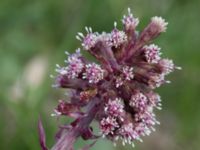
[100,91,161,146]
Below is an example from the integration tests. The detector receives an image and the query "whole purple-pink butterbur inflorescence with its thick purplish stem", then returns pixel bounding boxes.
[40,9,180,150]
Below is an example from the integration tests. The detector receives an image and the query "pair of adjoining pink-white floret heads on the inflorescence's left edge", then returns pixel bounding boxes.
[54,49,105,87]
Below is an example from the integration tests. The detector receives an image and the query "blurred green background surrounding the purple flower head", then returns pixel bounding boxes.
[0,0,200,150]
